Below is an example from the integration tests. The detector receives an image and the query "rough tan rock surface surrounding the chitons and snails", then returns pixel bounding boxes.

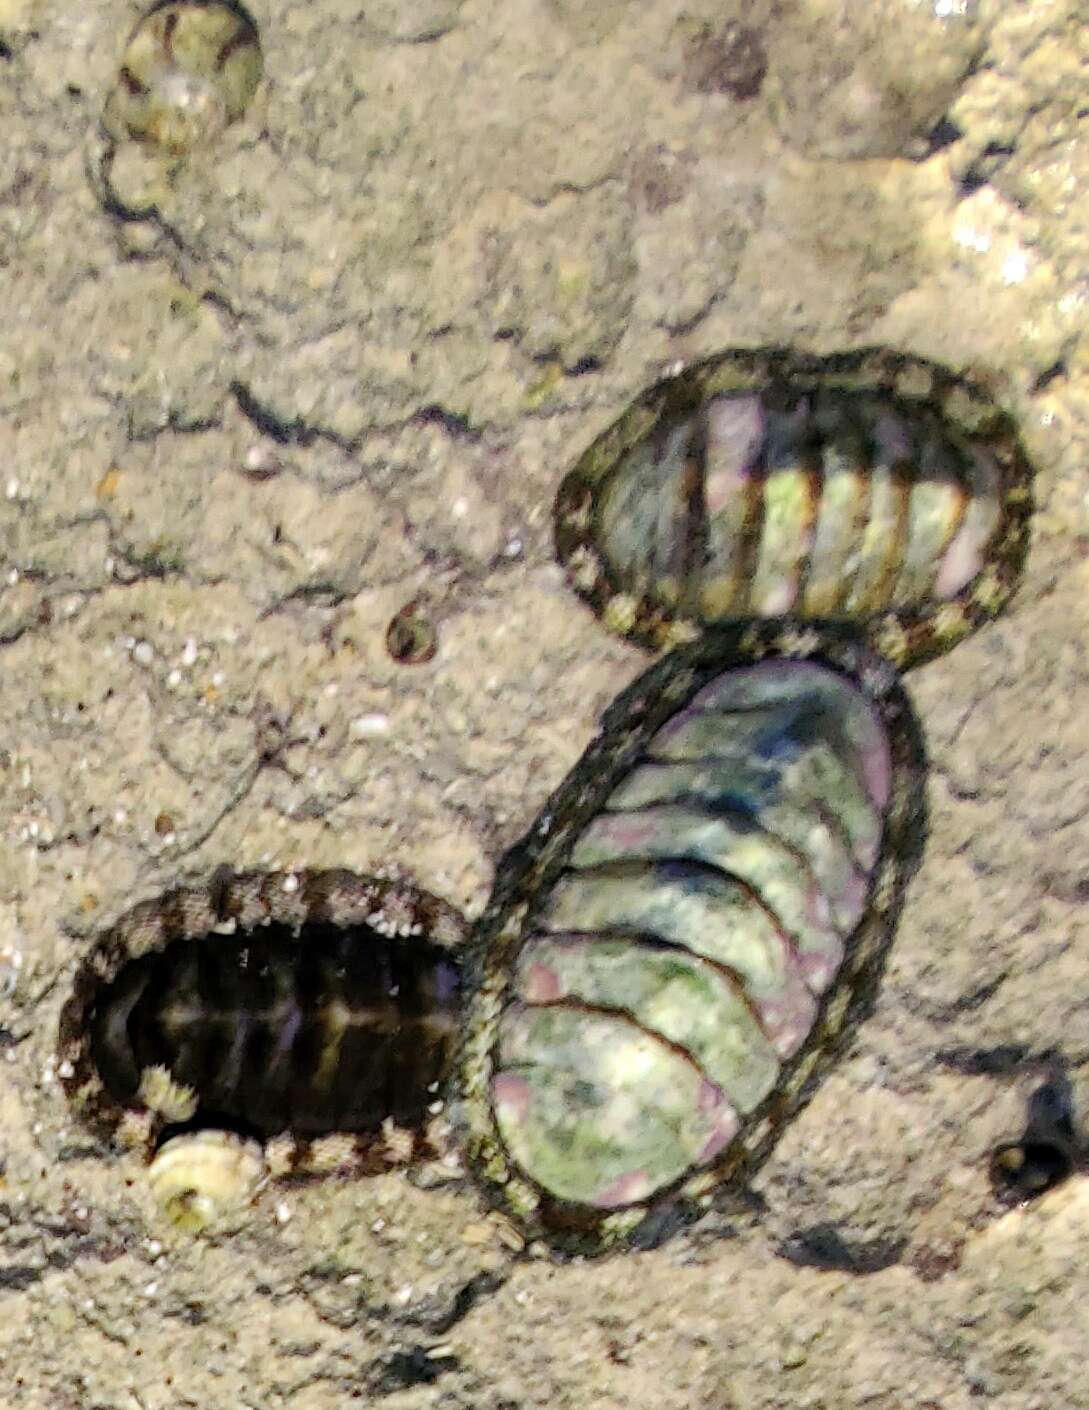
[0,0,1089,1410]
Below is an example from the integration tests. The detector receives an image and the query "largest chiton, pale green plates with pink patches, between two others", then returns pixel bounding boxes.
[460,623,923,1246]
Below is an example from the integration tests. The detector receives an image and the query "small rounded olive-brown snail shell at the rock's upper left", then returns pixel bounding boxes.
[103,0,262,157]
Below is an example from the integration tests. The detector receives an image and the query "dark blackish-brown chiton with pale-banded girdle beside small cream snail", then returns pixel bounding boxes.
[59,871,463,1172]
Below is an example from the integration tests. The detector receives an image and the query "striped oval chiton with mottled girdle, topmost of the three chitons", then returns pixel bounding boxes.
[556,350,1031,667]
